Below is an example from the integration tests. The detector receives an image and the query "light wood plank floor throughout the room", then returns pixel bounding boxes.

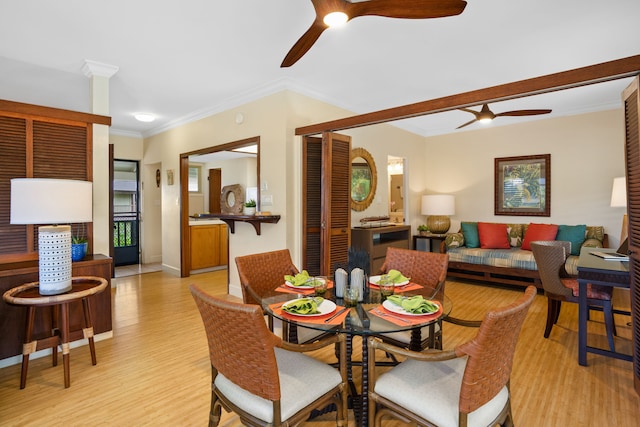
[0,271,640,427]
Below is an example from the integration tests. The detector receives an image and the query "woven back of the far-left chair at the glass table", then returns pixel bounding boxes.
[236,249,299,305]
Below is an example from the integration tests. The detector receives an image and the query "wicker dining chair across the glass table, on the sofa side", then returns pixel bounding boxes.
[372,247,449,351]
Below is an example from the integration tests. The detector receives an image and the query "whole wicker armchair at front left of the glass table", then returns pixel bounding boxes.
[189,285,348,427]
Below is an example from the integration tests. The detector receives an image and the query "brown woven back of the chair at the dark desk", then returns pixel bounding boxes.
[531,240,571,297]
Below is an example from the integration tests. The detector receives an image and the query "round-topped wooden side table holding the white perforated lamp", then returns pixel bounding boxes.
[3,276,107,389]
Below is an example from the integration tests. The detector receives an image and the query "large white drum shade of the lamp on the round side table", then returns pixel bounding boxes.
[10,178,93,224]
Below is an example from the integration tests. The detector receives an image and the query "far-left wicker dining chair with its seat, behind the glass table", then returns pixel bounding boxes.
[236,249,327,343]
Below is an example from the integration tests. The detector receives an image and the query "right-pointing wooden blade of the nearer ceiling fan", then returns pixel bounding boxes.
[352,0,467,19]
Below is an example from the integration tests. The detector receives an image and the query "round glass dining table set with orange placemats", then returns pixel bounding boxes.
[261,283,453,426]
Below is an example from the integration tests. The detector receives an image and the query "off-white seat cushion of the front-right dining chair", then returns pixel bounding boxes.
[375,357,509,427]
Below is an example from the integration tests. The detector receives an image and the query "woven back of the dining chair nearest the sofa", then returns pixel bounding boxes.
[380,247,449,288]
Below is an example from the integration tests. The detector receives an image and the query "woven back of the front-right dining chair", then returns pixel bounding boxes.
[455,286,536,414]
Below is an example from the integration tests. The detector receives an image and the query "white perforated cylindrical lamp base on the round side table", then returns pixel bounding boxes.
[38,225,71,295]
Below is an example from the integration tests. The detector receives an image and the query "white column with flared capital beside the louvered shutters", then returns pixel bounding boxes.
[82,60,118,255]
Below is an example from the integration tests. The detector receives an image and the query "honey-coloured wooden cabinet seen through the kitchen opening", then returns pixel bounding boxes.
[190,224,228,270]
